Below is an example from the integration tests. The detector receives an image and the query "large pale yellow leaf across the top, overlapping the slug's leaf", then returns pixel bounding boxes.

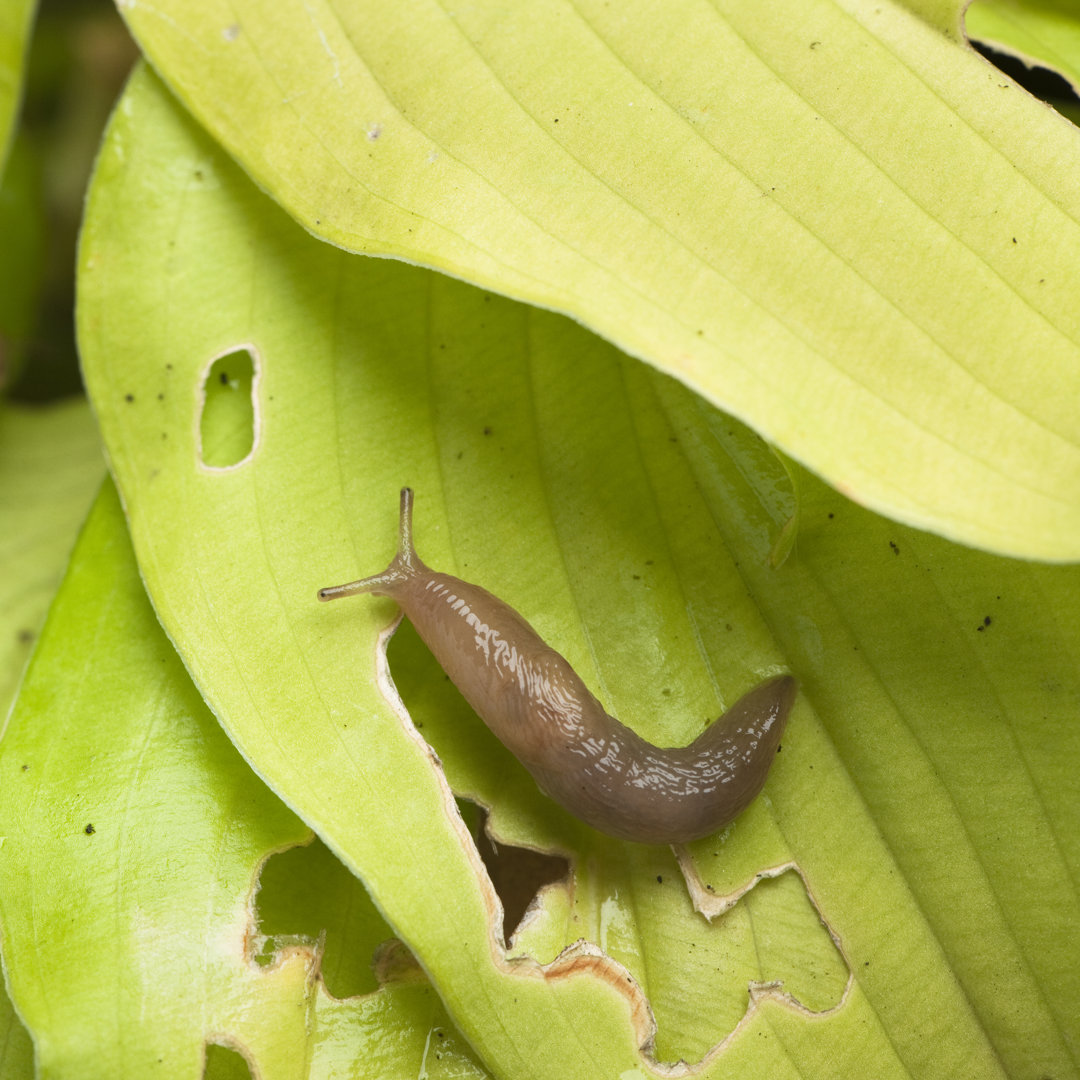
[111,0,1080,559]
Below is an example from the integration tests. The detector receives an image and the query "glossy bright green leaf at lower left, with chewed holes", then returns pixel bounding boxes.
[0,484,483,1080]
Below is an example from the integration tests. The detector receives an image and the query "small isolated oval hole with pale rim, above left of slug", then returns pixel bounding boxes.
[199,348,258,469]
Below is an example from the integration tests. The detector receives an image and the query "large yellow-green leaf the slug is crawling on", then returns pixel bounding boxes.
[71,72,1080,1080]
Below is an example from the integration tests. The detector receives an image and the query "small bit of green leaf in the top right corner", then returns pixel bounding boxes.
[964,0,1080,89]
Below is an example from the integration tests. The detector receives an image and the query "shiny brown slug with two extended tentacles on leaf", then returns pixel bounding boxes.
[319,487,796,843]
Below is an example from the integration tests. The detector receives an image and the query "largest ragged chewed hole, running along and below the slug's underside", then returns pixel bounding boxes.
[388,621,849,1063]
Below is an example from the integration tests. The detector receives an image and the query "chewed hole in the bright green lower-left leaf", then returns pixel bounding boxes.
[255,839,393,998]
